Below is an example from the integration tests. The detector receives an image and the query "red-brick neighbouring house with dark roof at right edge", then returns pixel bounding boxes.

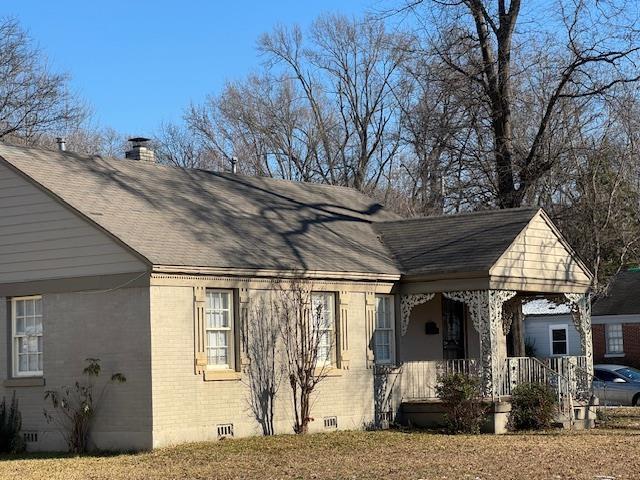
[591,270,640,368]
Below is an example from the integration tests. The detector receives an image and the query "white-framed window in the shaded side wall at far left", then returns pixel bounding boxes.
[11,296,43,377]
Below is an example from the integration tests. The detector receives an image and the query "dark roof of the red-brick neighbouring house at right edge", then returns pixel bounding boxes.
[591,270,640,316]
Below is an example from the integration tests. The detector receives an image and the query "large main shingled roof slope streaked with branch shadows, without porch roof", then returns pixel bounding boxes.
[0,145,399,274]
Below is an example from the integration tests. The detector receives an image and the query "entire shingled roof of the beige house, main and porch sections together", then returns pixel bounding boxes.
[0,144,536,275]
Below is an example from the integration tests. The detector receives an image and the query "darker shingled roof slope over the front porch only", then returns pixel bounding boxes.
[375,208,538,276]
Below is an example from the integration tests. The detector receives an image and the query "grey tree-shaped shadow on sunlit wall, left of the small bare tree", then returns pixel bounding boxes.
[246,295,282,435]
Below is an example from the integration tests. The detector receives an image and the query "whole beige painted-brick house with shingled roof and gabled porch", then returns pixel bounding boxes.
[0,144,591,450]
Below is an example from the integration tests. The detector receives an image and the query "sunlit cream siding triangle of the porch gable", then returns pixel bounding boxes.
[490,213,590,291]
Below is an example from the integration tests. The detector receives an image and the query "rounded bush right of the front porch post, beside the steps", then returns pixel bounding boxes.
[509,383,558,430]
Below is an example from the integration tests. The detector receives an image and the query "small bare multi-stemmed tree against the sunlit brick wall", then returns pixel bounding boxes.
[276,281,335,434]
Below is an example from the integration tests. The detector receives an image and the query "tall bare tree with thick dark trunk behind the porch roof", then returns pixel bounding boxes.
[396,0,640,208]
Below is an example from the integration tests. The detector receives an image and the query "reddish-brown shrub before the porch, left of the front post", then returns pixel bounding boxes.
[436,373,486,433]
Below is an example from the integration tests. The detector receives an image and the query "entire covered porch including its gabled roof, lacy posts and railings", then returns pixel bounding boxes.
[376,210,593,432]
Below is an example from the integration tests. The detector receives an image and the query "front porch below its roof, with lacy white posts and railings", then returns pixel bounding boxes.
[396,290,593,433]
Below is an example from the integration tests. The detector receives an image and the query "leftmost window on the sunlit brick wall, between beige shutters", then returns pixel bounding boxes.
[205,290,235,369]
